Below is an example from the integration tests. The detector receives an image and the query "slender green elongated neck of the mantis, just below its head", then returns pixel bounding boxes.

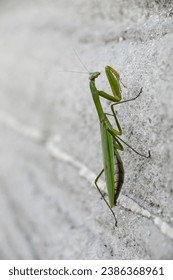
[90,80,105,121]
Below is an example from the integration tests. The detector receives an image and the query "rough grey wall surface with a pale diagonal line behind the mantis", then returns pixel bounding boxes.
[0,0,173,259]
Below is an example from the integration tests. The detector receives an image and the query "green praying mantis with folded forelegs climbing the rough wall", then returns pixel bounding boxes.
[89,66,150,226]
